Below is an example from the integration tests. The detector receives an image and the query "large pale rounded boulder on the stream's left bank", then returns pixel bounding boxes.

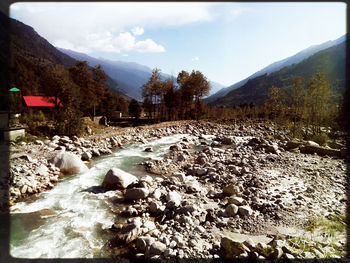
[49,152,89,174]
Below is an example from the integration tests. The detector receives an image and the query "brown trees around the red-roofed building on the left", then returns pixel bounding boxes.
[10,61,128,135]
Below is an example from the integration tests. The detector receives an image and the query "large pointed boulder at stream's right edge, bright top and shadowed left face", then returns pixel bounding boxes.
[102,168,137,190]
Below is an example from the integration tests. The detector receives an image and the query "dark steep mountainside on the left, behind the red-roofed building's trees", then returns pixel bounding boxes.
[0,14,128,98]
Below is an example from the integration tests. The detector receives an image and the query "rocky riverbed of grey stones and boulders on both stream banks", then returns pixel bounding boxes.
[4,121,348,259]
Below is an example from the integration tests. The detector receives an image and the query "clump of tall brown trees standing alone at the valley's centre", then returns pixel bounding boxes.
[129,68,210,121]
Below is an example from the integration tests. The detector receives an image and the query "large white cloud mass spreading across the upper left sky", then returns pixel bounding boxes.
[10,2,214,55]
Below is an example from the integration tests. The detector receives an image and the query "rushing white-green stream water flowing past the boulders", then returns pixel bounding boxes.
[10,134,197,258]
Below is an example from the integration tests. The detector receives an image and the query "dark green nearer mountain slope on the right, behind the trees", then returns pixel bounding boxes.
[209,41,346,107]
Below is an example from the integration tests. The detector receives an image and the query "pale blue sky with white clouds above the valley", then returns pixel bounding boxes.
[10,2,346,86]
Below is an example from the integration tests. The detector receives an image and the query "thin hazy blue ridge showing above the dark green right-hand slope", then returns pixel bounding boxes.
[205,35,346,103]
